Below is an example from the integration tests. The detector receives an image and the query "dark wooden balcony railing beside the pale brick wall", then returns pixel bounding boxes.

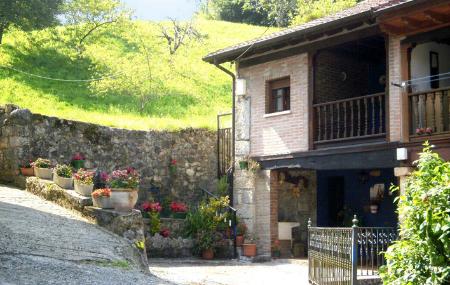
[313,93,386,143]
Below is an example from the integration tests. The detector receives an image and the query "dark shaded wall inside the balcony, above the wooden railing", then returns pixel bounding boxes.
[314,50,369,103]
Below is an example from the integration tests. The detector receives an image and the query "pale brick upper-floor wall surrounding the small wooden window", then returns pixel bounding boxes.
[239,53,309,156]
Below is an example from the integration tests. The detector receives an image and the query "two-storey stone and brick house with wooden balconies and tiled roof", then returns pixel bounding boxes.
[204,0,450,255]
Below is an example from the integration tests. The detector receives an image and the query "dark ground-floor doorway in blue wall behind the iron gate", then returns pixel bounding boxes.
[328,176,345,227]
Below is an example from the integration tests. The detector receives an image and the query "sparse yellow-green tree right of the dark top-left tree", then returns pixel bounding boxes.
[64,0,130,53]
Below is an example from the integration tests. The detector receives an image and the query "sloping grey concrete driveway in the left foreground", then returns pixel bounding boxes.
[0,186,171,285]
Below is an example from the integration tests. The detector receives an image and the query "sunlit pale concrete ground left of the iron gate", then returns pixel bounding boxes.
[149,259,308,285]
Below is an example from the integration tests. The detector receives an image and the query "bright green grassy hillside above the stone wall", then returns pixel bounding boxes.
[0,20,276,130]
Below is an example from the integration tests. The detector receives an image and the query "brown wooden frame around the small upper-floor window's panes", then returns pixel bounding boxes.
[266,77,291,114]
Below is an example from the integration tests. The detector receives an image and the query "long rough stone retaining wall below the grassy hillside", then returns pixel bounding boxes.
[0,105,217,204]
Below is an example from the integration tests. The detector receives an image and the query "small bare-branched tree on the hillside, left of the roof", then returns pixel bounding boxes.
[159,18,204,55]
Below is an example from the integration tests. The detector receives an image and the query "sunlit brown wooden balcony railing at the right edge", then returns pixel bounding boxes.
[408,87,450,136]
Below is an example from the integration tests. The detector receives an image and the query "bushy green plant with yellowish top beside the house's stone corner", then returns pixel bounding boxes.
[185,196,230,254]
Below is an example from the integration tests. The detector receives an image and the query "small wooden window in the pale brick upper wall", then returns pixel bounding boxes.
[266,78,291,114]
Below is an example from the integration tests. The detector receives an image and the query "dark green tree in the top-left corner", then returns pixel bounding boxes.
[0,0,63,44]
